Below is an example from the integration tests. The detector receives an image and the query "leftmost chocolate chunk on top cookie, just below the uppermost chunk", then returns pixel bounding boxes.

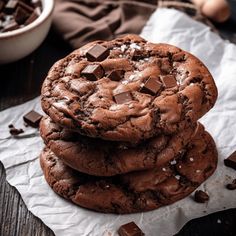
[81,64,104,81]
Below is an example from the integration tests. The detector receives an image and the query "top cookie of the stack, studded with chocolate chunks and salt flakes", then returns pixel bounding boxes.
[42,35,217,142]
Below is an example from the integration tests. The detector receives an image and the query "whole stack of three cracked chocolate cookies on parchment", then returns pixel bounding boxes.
[40,35,217,214]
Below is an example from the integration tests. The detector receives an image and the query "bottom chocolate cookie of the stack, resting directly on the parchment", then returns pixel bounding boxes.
[40,127,217,214]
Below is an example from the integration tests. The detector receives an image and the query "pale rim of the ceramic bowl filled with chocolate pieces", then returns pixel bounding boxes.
[0,0,55,39]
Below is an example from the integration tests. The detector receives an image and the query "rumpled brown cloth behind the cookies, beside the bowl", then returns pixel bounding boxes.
[53,0,158,48]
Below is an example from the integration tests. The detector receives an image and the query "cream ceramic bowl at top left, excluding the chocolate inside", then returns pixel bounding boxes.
[0,0,54,64]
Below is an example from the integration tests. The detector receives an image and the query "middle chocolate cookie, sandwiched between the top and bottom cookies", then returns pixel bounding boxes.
[40,117,197,176]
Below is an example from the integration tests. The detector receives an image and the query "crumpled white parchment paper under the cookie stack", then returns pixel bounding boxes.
[0,9,236,236]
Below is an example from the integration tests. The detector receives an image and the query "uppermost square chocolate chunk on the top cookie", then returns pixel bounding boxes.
[86,44,109,61]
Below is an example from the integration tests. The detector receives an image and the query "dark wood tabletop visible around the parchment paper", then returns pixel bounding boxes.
[0,16,236,236]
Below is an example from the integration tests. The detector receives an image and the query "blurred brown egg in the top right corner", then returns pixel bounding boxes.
[200,0,230,23]
